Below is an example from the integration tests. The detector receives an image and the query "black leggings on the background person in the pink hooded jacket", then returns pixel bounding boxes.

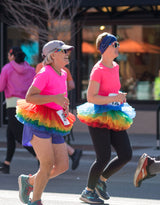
[5,108,36,162]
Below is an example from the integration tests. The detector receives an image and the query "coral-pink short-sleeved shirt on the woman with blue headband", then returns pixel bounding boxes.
[90,61,121,96]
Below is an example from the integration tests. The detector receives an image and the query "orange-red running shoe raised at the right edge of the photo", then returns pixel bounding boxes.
[133,153,155,187]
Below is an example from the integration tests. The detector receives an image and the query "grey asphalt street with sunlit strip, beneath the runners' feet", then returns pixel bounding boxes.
[0,149,160,205]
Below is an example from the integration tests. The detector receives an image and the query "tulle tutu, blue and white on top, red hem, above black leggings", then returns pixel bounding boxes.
[77,102,136,131]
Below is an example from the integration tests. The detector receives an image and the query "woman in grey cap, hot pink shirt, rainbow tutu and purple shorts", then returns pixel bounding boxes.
[17,40,75,205]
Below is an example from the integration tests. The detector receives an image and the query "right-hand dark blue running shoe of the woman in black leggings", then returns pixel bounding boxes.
[95,179,110,200]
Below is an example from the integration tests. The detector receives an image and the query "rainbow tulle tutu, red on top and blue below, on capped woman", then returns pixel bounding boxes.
[16,100,76,136]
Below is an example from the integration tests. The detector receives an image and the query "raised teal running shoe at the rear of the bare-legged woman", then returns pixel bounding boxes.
[18,175,33,204]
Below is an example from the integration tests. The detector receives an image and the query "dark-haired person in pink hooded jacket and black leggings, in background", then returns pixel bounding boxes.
[0,47,36,174]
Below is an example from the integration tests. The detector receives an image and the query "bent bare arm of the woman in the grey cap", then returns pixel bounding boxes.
[26,86,69,109]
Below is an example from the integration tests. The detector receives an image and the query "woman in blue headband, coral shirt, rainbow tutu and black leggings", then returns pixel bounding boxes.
[77,32,135,204]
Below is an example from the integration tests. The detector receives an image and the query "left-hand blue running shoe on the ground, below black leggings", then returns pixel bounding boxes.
[80,189,104,204]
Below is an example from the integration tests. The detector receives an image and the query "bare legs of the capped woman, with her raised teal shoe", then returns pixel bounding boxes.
[18,133,68,203]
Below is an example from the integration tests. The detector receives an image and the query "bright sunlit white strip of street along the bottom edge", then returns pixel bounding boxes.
[0,191,159,205]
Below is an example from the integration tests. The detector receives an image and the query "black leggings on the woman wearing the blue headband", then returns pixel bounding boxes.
[88,127,132,189]
